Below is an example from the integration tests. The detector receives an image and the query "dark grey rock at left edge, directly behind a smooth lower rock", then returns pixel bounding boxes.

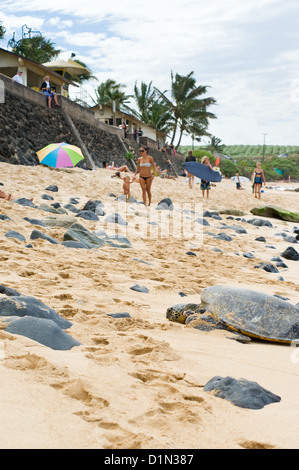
[0,295,72,329]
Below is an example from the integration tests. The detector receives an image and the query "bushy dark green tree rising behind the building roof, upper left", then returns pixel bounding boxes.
[13,36,61,64]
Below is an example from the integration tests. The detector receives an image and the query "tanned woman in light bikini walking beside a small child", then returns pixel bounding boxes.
[133,147,157,206]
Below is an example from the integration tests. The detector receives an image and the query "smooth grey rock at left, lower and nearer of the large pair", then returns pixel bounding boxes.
[5,316,81,351]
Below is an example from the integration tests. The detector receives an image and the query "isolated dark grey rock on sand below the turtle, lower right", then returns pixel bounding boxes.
[204,376,281,410]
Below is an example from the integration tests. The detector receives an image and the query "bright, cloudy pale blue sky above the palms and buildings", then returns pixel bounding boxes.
[0,0,299,145]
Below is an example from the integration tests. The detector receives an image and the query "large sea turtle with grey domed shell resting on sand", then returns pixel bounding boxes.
[166,286,299,343]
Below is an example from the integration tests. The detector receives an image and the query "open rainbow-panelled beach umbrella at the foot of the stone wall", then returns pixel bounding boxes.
[36,142,84,168]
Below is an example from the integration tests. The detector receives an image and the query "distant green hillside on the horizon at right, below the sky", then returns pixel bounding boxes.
[180,145,299,159]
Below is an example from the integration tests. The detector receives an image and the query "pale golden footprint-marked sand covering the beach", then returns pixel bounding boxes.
[0,163,299,449]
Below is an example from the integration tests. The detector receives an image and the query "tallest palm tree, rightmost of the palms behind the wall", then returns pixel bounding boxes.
[156,72,216,148]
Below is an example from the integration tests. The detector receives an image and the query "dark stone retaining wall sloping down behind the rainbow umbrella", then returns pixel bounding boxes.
[0,74,188,174]
